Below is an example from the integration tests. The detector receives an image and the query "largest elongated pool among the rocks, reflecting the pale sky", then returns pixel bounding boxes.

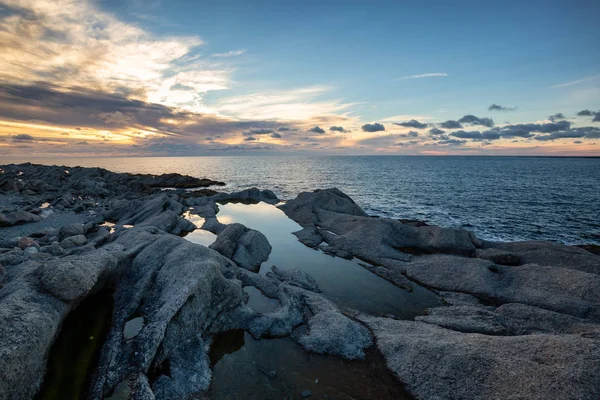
[217,203,441,319]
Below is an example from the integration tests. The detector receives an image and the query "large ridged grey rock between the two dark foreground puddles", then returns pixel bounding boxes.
[90,227,250,399]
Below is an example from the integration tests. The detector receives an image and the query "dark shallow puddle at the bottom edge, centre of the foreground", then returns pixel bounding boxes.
[210,331,411,400]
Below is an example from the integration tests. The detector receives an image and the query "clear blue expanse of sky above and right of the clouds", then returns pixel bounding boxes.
[101,1,600,120]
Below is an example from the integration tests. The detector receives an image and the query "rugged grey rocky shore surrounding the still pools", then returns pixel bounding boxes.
[0,164,600,400]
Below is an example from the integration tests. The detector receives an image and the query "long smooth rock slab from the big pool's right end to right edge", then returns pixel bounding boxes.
[406,255,600,319]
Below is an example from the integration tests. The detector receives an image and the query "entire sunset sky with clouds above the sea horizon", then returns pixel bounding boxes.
[0,0,600,157]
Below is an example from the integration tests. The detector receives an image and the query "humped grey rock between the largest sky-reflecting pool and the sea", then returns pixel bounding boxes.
[280,189,475,280]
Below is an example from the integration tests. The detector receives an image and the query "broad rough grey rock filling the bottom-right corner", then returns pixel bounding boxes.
[359,315,600,400]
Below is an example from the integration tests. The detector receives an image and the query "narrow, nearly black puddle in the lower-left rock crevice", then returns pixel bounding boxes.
[35,290,113,400]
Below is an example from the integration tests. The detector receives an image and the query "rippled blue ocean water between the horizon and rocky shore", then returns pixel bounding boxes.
[2,156,600,244]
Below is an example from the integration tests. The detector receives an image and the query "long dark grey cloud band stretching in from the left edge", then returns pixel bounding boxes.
[0,83,288,137]
